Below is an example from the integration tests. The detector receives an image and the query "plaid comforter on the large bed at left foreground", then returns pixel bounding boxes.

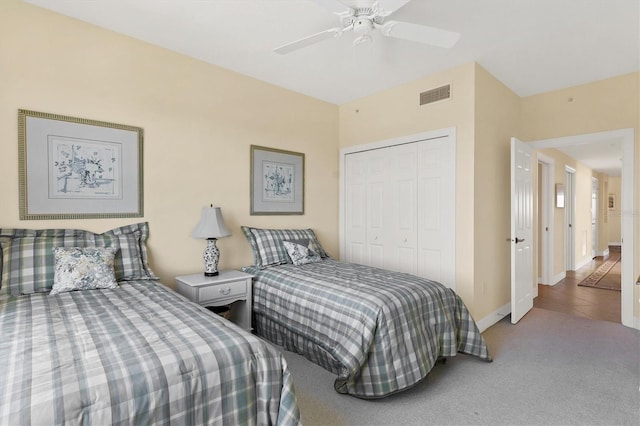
[0,281,299,425]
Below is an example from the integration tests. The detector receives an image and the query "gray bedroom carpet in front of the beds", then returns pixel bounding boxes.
[284,308,640,426]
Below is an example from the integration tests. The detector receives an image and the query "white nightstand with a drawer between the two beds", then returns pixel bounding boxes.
[176,270,253,331]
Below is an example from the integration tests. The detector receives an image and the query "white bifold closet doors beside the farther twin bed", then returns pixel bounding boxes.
[343,137,455,288]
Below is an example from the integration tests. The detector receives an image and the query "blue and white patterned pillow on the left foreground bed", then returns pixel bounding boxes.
[49,247,118,295]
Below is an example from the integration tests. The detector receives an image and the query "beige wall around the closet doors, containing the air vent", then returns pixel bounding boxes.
[339,63,476,313]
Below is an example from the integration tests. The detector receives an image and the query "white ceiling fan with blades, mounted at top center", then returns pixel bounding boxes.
[274,0,460,54]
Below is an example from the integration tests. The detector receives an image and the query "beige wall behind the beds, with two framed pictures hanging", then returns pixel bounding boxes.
[0,0,338,286]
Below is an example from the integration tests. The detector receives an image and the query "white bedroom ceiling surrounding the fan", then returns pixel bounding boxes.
[24,0,640,176]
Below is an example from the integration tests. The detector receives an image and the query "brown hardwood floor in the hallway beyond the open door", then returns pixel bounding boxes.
[533,250,621,323]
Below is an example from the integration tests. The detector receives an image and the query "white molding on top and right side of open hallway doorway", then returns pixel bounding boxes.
[530,128,640,329]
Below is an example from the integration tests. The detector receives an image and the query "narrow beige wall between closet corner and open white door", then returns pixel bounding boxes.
[473,65,524,318]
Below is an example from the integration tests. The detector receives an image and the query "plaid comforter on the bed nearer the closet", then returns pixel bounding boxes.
[244,259,491,398]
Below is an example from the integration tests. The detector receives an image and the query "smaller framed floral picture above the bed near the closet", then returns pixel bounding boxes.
[251,145,304,215]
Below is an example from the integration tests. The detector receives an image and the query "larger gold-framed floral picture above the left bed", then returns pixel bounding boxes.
[18,109,143,220]
